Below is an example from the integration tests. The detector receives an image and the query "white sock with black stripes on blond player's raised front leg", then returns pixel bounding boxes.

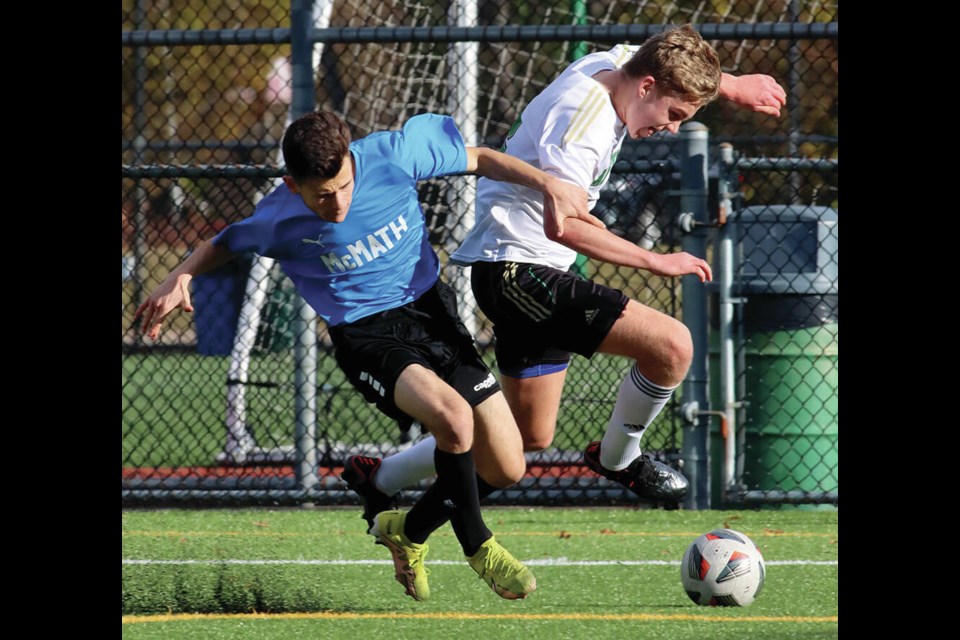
[600,364,676,471]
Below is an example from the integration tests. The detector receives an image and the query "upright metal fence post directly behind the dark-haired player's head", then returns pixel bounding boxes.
[290,0,320,492]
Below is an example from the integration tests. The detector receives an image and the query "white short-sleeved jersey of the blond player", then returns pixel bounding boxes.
[451,45,638,270]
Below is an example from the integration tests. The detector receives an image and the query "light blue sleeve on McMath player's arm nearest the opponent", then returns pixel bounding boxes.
[397,113,467,180]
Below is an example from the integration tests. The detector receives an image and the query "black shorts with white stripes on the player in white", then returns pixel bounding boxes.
[471,262,629,378]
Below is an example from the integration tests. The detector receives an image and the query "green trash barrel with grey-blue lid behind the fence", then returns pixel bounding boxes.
[736,205,839,503]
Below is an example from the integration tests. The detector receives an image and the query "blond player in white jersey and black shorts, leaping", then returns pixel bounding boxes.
[344,25,786,511]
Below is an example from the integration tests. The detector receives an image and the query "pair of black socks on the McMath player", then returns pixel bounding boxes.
[404,449,493,555]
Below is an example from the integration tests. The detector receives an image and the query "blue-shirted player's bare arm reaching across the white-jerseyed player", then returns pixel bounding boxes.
[467,147,605,240]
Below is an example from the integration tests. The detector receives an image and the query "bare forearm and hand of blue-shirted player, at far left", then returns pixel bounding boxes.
[133,240,234,340]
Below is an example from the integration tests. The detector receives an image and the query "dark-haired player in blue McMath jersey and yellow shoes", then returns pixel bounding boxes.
[136,111,600,600]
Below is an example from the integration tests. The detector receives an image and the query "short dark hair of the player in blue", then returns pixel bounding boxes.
[281,110,350,182]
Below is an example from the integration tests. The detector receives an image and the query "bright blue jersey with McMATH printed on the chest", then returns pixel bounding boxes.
[213,114,467,325]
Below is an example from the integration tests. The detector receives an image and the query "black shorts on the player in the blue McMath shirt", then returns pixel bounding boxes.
[330,280,500,428]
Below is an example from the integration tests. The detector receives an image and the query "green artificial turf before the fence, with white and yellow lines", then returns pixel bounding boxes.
[121,507,839,640]
